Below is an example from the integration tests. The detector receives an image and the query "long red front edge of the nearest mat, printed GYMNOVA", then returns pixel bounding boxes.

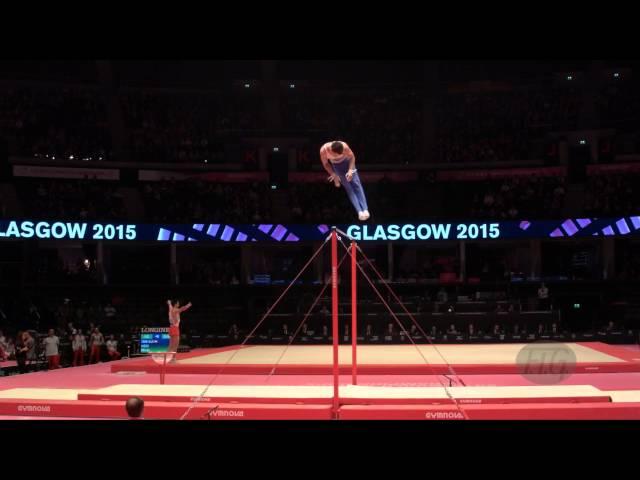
[0,399,640,421]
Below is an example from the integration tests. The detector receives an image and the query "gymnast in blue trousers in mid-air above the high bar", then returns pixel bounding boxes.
[320,141,370,221]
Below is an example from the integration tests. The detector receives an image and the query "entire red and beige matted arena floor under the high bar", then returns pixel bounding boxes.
[0,342,640,420]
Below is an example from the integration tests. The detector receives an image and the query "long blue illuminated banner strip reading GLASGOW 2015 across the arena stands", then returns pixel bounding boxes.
[0,216,640,243]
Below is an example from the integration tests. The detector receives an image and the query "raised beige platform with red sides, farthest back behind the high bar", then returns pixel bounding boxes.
[112,342,640,375]
